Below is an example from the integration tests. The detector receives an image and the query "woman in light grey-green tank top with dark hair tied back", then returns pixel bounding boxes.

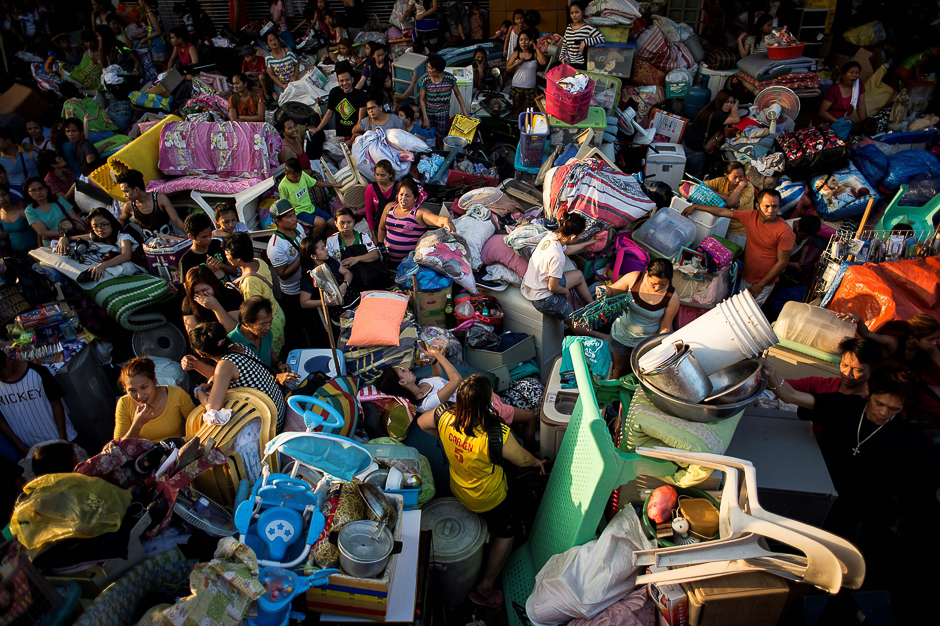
[605,259,679,380]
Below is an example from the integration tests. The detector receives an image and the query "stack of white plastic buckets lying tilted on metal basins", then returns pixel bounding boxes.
[664,291,777,375]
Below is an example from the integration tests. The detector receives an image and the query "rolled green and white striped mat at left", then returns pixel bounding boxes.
[87,274,173,331]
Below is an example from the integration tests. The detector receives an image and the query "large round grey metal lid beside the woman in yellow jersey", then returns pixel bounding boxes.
[421,498,486,563]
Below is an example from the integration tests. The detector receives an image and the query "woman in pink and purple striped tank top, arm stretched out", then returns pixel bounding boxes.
[378,176,457,265]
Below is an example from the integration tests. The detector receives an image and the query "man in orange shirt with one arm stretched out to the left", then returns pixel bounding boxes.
[683,189,796,305]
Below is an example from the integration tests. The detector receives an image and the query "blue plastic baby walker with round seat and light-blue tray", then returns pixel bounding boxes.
[235,432,372,568]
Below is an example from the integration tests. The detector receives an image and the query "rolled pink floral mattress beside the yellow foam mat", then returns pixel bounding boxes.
[158,122,283,179]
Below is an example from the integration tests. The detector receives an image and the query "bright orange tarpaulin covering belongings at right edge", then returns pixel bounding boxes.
[829,257,940,331]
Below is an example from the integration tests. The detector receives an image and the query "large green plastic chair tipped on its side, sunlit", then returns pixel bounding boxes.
[503,343,676,626]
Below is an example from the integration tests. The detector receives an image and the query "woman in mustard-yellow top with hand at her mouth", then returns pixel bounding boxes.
[114,358,196,441]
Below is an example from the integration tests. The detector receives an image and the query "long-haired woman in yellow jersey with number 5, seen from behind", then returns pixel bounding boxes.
[418,374,545,608]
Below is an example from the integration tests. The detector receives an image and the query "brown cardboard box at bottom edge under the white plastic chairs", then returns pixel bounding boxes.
[682,572,790,626]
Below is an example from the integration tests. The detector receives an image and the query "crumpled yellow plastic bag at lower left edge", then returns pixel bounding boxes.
[10,474,131,550]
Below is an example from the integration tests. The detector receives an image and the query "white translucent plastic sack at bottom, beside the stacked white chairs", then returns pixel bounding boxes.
[525,506,655,626]
